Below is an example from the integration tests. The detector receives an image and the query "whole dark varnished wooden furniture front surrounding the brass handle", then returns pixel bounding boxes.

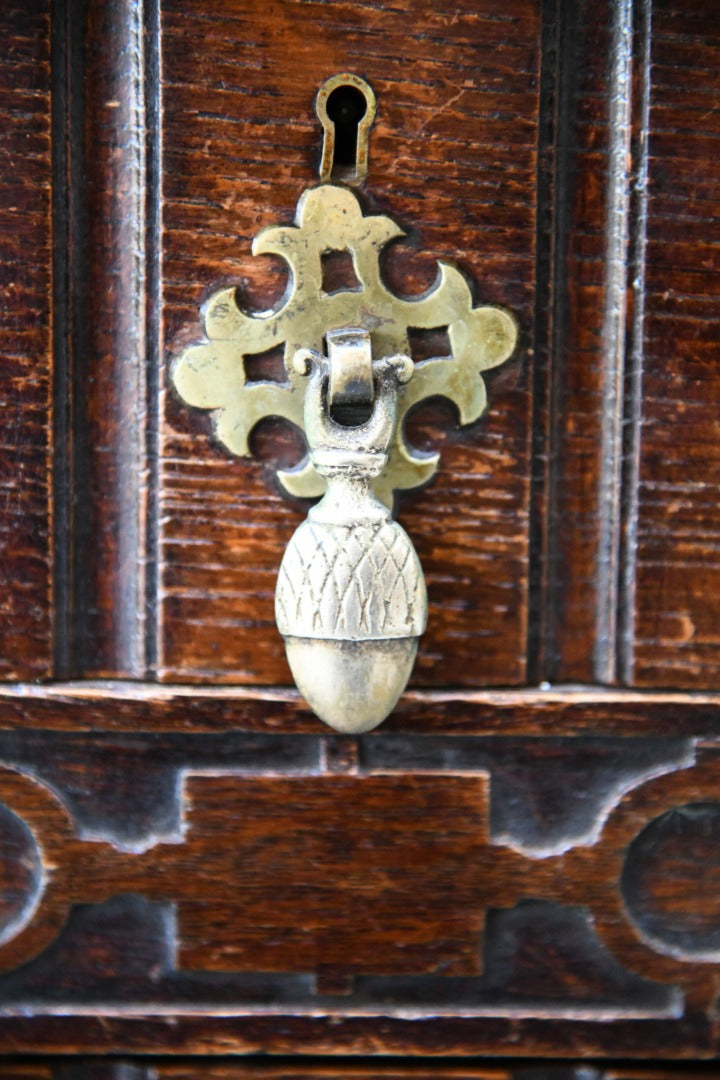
[0,0,720,1067]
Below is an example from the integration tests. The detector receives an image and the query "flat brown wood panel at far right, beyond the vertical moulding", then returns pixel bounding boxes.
[631,0,720,688]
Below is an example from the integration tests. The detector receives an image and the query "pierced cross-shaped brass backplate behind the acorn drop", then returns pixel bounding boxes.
[173,184,517,505]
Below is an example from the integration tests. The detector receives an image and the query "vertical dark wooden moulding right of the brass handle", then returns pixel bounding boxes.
[530,2,649,684]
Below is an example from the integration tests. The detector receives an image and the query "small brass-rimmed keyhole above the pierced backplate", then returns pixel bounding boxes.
[315,72,376,184]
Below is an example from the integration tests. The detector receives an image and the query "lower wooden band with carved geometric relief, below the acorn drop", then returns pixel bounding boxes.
[0,691,720,1057]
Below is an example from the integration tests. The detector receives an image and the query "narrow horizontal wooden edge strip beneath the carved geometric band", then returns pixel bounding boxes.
[0,1007,718,1062]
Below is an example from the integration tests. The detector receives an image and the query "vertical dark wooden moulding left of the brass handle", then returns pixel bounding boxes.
[54,0,157,677]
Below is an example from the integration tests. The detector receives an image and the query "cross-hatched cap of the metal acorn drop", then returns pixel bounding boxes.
[275,521,425,640]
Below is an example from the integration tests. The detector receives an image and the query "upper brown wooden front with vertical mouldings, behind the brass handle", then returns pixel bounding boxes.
[7,0,720,689]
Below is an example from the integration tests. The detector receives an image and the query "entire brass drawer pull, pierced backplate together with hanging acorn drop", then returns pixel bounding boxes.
[173,77,517,732]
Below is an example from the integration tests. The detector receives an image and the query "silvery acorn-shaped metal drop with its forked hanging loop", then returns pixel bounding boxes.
[275,330,427,733]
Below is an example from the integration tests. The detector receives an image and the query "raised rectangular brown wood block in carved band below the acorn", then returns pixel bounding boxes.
[178,775,491,977]
